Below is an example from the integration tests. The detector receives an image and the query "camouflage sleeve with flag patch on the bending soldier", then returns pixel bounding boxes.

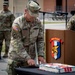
[9,18,31,61]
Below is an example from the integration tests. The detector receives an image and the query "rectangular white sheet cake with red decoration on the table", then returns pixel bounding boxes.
[39,63,75,73]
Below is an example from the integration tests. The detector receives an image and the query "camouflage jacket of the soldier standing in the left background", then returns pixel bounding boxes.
[0,10,15,31]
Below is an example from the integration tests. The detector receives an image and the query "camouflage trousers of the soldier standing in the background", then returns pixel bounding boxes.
[0,31,11,55]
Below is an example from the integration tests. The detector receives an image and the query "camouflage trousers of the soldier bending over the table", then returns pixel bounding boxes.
[6,60,27,75]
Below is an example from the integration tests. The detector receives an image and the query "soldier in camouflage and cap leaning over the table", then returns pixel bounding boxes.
[8,1,46,75]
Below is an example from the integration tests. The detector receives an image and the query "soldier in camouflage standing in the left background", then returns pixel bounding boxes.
[0,2,15,59]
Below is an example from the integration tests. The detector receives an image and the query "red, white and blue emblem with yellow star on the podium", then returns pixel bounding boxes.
[50,38,62,59]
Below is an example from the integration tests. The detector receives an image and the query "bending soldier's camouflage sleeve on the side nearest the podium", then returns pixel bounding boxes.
[37,22,44,57]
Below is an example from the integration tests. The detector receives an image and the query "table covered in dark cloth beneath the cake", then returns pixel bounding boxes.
[15,67,75,75]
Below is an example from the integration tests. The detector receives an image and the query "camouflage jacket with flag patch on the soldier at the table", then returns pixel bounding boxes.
[9,15,44,61]
